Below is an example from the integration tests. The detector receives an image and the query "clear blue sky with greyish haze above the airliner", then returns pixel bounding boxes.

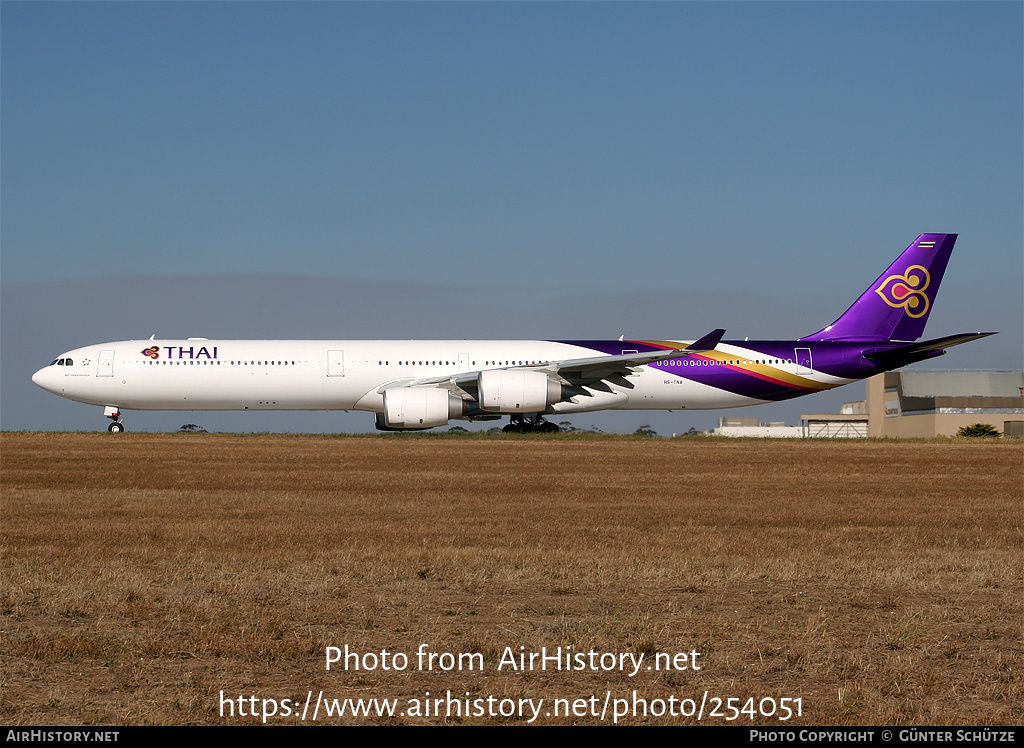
[0,2,1024,431]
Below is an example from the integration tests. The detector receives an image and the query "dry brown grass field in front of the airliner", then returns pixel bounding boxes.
[0,432,1024,726]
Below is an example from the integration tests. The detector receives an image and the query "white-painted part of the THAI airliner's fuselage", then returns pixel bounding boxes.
[33,339,849,413]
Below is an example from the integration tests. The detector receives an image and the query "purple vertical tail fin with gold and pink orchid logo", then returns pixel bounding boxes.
[801,234,956,341]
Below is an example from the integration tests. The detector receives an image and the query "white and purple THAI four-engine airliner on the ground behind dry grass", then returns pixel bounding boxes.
[32,234,995,432]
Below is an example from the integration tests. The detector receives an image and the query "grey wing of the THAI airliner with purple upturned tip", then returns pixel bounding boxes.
[378,330,725,401]
